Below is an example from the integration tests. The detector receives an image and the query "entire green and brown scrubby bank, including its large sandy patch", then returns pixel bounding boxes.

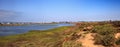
[0,21,120,47]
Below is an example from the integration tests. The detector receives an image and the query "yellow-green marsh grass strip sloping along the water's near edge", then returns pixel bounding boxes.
[0,26,69,47]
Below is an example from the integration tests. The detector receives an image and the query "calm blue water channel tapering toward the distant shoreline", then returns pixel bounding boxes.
[0,24,73,36]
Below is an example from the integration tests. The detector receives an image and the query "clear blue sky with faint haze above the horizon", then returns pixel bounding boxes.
[0,0,120,22]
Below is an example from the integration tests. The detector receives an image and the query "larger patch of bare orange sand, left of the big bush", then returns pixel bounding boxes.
[77,33,103,47]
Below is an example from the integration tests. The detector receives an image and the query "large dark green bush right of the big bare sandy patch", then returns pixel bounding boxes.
[92,24,116,46]
